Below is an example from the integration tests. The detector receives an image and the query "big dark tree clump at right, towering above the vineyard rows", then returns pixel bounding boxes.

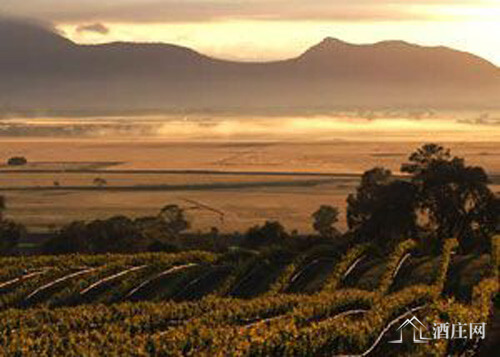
[347,144,499,253]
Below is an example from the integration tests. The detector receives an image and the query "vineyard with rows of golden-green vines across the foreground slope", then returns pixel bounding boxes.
[0,237,500,356]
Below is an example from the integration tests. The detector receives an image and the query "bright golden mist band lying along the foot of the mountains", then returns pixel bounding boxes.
[0,111,500,141]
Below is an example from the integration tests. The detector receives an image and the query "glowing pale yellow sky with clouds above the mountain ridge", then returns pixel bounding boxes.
[0,0,500,65]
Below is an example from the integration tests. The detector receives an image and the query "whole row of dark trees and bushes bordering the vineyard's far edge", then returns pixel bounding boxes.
[0,144,500,254]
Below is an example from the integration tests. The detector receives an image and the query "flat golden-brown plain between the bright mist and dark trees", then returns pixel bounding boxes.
[0,138,500,232]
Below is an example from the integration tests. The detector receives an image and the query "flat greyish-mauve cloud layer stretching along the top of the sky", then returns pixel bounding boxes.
[2,0,494,23]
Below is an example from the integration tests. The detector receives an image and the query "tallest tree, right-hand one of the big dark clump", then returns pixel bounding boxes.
[401,144,498,252]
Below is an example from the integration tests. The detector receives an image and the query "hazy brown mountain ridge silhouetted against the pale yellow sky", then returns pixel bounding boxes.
[0,19,500,111]
